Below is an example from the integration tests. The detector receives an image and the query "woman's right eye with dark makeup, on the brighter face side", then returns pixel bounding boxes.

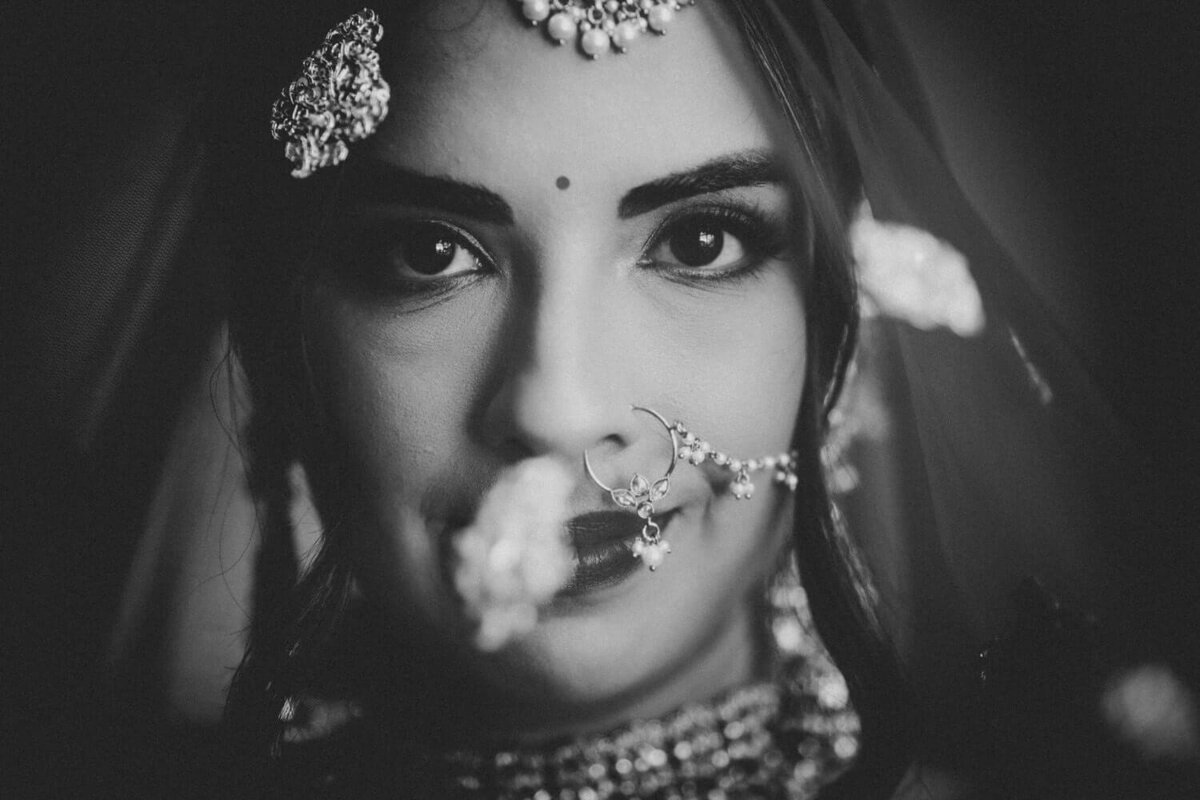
[638,207,781,279]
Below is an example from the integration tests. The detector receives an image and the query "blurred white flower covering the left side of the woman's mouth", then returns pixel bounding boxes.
[455,457,575,650]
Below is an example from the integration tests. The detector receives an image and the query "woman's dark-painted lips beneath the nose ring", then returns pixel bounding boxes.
[557,510,676,597]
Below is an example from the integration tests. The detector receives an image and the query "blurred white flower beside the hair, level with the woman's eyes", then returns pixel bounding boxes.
[850,200,985,336]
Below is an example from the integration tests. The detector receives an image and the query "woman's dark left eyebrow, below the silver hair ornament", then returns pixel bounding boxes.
[341,158,514,225]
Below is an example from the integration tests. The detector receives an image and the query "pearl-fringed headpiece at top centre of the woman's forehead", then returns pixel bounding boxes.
[517,0,696,59]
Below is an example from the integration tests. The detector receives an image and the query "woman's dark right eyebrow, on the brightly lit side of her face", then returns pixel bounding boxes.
[617,150,784,219]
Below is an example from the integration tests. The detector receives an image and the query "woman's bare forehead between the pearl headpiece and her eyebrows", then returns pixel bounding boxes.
[368,0,779,195]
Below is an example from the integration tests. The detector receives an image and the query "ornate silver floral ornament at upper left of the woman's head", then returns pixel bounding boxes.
[271,8,391,178]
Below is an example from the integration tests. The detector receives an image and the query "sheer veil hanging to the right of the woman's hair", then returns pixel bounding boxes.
[772,0,1194,796]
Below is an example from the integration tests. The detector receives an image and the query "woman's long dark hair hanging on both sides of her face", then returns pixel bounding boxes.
[217,0,910,796]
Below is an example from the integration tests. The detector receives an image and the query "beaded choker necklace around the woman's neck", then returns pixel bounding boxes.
[445,647,859,800]
